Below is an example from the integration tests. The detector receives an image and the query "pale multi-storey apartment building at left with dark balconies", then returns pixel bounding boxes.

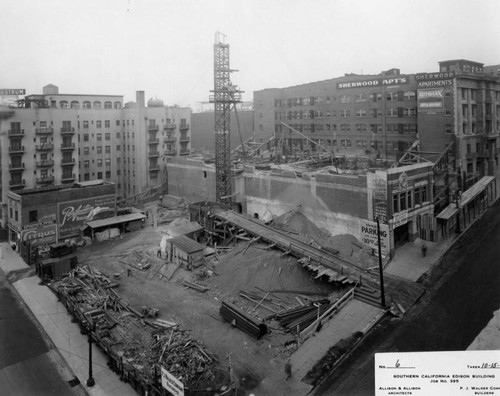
[0,85,191,227]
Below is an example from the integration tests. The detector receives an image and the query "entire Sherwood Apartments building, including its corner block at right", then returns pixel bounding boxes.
[254,59,500,187]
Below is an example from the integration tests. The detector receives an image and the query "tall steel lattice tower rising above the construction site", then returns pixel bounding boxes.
[210,32,242,204]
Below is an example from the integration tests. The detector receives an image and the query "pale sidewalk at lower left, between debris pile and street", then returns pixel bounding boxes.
[0,243,137,396]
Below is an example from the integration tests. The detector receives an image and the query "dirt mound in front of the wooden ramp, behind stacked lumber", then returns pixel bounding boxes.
[212,243,332,295]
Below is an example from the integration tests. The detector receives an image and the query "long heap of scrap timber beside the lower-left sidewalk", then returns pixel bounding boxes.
[50,266,230,395]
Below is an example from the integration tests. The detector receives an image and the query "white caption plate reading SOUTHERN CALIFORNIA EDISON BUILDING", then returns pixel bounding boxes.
[375,351,500,396]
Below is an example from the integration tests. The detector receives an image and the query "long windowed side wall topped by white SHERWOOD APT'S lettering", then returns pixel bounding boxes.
[254,69,418,158]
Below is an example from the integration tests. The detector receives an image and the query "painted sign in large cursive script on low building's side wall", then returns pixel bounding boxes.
[57,195,116,238]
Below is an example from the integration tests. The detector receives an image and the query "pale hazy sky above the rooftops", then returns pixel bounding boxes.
[0,0,500,109]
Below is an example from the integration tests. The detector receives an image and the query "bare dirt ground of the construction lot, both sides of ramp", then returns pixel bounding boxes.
[70,203,371,394]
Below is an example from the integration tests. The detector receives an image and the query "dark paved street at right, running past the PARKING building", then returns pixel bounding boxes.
[315,202,500,396]
